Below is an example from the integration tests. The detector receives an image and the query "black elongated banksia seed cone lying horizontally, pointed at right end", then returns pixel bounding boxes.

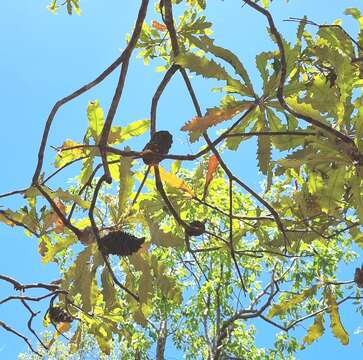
[100,231,145,256]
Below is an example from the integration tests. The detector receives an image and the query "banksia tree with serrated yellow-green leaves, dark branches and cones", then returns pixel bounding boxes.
[0,0,363,359]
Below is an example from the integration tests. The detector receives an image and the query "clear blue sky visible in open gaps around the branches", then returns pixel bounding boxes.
[0,0,363,360]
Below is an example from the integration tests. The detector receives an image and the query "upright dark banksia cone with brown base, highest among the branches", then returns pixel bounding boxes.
[142,131,173,165]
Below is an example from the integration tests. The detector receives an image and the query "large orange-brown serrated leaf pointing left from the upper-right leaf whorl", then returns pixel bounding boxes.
[181,103,252,132]
